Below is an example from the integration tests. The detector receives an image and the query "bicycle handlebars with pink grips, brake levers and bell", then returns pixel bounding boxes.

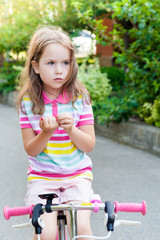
[4,193,146,240]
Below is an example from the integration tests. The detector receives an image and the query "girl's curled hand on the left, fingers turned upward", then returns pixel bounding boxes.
[39,116,59,133]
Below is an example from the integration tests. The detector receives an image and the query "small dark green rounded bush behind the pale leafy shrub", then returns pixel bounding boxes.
[101,66,125,91]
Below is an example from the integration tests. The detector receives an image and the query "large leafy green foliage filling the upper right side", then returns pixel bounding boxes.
[72,0,160,126]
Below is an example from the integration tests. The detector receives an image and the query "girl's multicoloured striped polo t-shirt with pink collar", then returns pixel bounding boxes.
[19,92,94,181]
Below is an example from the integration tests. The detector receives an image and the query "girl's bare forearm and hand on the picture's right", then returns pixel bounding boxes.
[57,113,95,152]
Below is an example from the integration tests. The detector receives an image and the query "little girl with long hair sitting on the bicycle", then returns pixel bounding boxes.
[18,27,95,240]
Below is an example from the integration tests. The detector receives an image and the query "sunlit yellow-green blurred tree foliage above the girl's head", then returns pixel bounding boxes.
[0,0,83,53]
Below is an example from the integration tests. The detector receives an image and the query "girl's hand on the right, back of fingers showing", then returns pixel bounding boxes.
[56,113,73,133]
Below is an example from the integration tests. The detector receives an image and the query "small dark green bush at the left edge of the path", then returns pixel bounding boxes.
[0,62,23,94]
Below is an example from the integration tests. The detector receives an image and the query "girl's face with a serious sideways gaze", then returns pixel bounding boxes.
[32,43,70,96]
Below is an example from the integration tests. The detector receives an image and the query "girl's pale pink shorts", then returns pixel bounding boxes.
[25,177,93,206]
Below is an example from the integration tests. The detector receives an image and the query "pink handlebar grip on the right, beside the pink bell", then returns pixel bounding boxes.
[114,201,146,215]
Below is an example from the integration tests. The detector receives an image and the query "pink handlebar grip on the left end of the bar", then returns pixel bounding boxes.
[3,205,33,220]
